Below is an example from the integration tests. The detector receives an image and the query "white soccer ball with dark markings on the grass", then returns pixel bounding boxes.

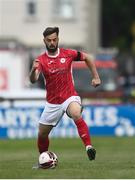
[39,151,58,169]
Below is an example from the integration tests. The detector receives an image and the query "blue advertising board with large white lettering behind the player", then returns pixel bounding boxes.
[0,104,135,139]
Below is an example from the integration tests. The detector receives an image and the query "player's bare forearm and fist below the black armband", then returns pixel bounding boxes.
[83,53,101,87]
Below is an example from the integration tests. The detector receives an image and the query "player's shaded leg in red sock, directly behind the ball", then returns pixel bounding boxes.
[37,123,53,153]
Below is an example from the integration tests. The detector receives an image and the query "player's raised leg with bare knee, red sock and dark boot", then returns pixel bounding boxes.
[67,102,96,160]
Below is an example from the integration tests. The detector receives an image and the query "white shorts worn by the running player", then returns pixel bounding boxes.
[39,96,81,126]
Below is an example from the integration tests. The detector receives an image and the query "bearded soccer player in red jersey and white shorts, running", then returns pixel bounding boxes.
[30,27,101,166]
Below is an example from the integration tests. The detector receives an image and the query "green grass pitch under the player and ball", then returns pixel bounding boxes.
[0,137,135,179]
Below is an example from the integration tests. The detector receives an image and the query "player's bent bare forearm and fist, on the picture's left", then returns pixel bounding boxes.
[30,59,40,83]
